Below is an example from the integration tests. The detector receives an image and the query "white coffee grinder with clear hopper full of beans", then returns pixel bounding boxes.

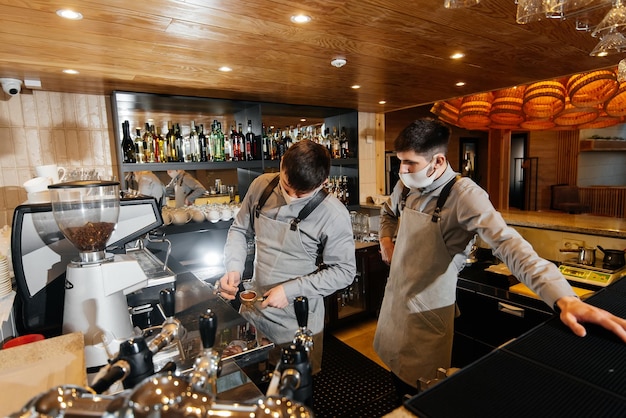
[49,180,147,371]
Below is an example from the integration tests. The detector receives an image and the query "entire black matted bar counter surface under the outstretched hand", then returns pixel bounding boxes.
[405,280,626,418]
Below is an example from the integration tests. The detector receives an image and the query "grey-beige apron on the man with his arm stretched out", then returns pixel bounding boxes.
[374,204,457,387]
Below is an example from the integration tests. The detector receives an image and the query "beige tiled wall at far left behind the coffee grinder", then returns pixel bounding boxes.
[0,91,118,226]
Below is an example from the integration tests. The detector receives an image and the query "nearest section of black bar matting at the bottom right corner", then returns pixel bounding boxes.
[405,351,626,418]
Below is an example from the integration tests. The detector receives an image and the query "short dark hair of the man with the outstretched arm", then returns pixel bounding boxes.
[393,118,450,156]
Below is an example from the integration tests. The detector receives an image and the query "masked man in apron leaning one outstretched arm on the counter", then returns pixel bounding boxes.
[374,119,626,394]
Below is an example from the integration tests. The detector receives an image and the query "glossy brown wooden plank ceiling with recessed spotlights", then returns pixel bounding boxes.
[0,0,623,120]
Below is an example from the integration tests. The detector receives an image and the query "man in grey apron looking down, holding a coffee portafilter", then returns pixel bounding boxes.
[219,140,356,373]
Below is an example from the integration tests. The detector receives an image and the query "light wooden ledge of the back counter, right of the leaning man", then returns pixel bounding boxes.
[500,210,626,238]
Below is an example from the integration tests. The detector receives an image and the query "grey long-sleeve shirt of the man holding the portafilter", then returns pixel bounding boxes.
[224,174,356,300]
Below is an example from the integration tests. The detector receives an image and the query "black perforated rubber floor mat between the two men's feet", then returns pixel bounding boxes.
[313,333,402,418]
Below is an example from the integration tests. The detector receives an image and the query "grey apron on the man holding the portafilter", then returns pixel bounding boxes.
[240,214,324,370]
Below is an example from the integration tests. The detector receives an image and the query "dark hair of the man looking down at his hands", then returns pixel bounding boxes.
[280,140,330,193]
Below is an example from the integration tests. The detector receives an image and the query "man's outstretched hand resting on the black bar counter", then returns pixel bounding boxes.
[557,296,626,343]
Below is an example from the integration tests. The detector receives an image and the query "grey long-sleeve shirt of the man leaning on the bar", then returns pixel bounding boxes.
[380,165,576,307]
